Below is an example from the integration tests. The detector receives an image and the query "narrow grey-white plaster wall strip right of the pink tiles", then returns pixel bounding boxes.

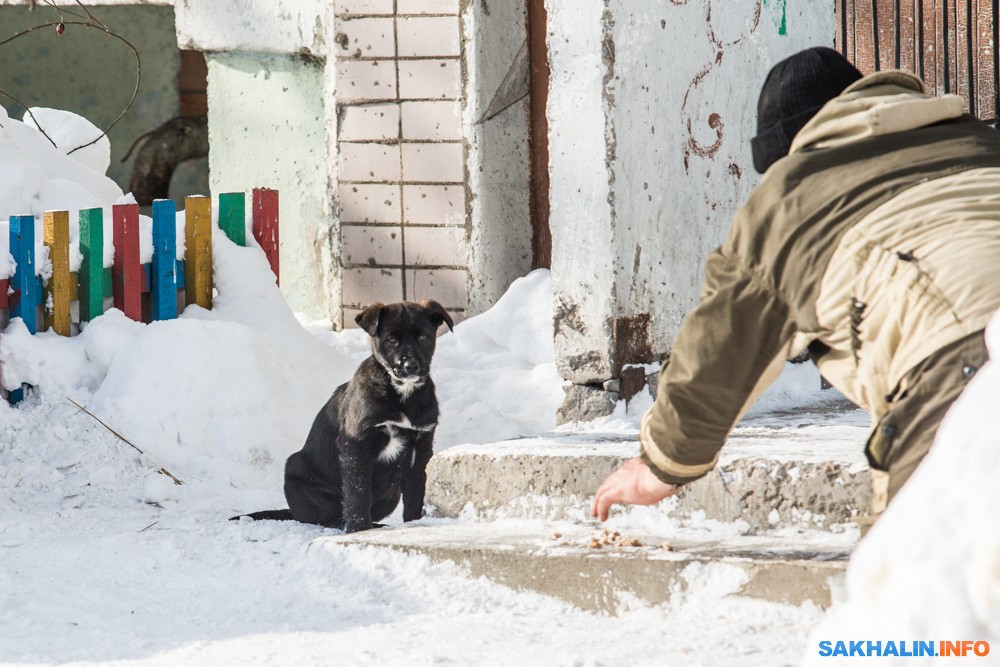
[463,0,532,314]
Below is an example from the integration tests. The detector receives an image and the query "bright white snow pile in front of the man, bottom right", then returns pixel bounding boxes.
[805,314,1000,665]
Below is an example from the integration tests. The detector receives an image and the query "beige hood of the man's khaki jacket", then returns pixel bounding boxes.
[789,70,965,154]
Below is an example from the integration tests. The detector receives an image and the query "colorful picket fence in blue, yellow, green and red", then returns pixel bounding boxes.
[0,188,278,402]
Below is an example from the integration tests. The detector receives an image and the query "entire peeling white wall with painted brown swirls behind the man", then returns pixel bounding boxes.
[546,0,834,402]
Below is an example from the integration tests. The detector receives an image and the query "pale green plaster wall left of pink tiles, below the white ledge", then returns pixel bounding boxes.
[208,53,340,318]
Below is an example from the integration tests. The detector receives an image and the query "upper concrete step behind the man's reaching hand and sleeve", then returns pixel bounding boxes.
[427,404,871,532]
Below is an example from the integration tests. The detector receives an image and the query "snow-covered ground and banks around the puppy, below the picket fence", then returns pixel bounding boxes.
[0,253,852,665]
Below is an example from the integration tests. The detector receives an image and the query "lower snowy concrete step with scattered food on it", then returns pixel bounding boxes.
[332,519,856,614]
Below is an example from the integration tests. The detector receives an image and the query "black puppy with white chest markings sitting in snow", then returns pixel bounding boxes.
[234,301,454,533]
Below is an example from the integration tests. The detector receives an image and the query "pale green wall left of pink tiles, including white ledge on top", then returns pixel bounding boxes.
[176,0,341,325]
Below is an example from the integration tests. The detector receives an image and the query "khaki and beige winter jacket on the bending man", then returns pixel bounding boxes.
[640,72,1000,484]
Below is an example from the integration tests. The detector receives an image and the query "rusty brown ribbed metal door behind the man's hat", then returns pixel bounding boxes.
[835,0,1000,123]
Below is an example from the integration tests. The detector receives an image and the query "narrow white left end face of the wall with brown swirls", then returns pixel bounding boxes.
[546,0,618,384]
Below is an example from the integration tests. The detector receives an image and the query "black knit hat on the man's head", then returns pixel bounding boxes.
[750,46,861,174]
